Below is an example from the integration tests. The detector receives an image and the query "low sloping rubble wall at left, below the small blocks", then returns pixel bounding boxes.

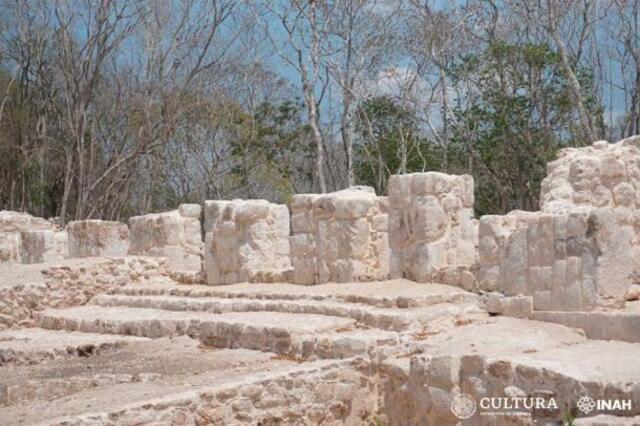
[0,256,164,330]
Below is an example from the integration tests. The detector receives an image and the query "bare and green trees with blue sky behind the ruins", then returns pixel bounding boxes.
[0,0,640,221]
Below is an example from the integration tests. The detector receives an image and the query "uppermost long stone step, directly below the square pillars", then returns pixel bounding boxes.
[114,279,479,308]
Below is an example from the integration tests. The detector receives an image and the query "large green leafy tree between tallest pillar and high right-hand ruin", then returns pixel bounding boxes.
[451,43,601,214]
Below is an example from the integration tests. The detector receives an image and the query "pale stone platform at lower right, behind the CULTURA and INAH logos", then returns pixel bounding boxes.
[382,317,640,425]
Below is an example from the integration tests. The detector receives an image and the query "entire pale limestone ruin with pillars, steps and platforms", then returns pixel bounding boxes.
[0,137,640,426]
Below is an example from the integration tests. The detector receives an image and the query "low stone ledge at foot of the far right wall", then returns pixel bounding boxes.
[533,303,640,343]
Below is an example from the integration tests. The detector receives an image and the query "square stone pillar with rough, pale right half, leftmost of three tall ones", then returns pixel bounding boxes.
[204,200,291,285]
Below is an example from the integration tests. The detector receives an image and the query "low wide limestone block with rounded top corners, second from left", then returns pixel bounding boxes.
[66,220,129,258]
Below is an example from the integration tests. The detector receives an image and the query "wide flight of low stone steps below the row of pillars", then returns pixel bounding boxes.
[28,282,486,360]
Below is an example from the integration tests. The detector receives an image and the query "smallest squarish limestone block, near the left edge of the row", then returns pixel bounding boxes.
[20,230,68,263]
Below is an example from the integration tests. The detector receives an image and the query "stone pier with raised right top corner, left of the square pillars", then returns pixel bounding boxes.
[129,204,203,271]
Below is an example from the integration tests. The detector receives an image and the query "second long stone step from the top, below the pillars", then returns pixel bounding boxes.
[91,294,419,331]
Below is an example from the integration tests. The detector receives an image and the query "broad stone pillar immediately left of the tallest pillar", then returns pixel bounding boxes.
[291,187,389,284]
